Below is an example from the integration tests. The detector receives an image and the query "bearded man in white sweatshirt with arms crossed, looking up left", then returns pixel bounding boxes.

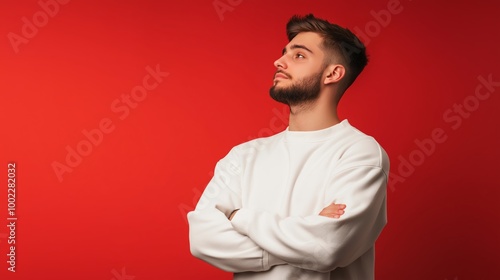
[188,15,389,280]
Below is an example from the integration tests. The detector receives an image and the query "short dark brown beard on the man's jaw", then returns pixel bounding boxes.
[269,72,322,106]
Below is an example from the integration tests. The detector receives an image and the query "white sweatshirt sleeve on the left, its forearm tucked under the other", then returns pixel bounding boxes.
[187,149,285,272]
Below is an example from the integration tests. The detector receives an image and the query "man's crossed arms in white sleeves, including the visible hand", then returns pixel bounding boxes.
[188,141,387,272]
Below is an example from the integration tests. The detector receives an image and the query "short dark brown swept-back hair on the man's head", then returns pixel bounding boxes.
[286,14,368,90]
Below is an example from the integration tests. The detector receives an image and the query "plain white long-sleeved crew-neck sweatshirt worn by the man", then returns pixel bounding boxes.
[188,120,389,280]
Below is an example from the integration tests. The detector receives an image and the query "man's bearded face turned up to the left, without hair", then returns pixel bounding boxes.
[269,32,325,106]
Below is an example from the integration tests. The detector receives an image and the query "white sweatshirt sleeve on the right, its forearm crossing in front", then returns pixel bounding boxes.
[231,140,389,272]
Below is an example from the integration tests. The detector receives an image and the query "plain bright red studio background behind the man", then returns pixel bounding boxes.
[0,0,500,280]
